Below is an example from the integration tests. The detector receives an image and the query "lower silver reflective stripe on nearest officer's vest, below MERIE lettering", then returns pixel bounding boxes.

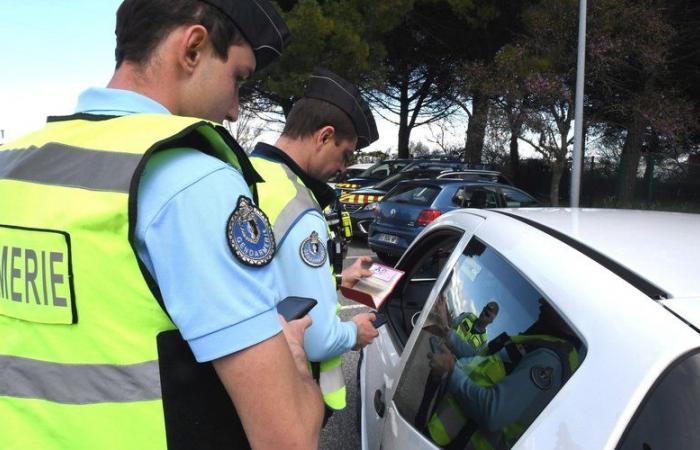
[0,355,161,405]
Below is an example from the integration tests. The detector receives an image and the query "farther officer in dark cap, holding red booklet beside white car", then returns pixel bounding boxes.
[251,69,378,412]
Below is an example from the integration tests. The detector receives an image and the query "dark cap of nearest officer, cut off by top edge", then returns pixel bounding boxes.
[201,0,292,71]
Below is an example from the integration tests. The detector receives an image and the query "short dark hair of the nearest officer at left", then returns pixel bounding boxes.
[114,0,243,68]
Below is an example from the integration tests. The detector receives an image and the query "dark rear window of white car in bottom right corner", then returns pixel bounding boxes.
[617,351,700,450]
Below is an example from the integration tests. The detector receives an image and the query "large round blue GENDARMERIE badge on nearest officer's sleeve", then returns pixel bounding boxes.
[226,195,276,267]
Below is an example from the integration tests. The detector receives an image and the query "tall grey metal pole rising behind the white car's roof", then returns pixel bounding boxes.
[570,0,586,208]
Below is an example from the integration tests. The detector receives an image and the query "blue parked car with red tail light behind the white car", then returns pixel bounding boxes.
[367,178,539,263]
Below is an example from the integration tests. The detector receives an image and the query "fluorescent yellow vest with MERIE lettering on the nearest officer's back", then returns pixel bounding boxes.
[0,114,254,450]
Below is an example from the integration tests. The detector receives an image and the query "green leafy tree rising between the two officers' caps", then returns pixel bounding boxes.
[241,0,414,116]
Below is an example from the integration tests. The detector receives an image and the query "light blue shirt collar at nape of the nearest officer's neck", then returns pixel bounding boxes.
[75,88,170,116]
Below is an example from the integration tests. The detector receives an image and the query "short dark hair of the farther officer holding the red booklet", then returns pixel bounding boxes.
[282,97,357,142]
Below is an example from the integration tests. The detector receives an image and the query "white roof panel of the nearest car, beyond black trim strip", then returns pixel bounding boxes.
[492,208,700,298]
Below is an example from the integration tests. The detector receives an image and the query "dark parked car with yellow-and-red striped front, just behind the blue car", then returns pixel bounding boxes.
[339,166,460,238]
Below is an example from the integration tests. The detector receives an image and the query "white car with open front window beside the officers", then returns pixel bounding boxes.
[358,208,700,450]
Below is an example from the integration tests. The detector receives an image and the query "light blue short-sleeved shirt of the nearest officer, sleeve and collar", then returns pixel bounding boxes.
[76,88,281,362]
